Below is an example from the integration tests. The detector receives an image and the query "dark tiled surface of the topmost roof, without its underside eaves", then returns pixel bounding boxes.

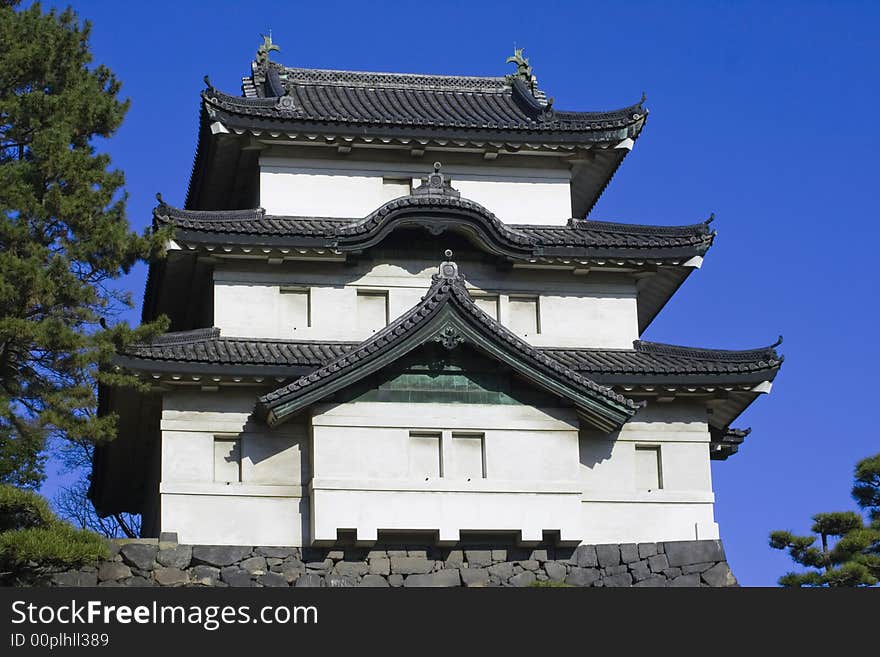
[209,63,647,142]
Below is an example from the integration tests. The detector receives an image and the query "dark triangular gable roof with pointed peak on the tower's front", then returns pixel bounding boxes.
[257,262,638,430]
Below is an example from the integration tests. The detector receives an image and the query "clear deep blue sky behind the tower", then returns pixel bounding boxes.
[37,0,880,585]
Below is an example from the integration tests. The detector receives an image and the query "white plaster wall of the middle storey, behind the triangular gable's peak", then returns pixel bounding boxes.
[214,260,638,349]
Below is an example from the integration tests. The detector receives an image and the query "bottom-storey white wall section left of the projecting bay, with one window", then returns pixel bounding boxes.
[159,390,310,545]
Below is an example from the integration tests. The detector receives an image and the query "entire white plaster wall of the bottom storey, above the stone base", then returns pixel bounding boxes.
[160,389,718,545]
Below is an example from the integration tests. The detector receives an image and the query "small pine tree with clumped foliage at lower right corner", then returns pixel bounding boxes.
[770,454,880,587]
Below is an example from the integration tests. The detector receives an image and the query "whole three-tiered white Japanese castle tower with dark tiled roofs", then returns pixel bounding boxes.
[91,39,782,547]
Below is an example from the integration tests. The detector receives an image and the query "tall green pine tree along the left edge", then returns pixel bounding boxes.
[0,0,167,487]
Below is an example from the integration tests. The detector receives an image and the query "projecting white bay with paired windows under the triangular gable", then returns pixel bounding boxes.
[310,403,580,543]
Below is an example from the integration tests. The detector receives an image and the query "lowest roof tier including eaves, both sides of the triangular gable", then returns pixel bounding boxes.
[118,327,783,448]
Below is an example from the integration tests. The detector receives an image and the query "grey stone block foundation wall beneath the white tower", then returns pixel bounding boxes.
[45,539,737,587]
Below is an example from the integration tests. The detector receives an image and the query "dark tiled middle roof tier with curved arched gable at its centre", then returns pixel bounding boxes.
[154,193,715,260]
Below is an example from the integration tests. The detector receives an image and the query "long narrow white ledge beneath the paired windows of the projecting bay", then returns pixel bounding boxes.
[309,477,583,495]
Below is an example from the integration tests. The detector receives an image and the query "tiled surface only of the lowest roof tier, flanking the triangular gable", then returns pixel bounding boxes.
[129,328,783,383]
